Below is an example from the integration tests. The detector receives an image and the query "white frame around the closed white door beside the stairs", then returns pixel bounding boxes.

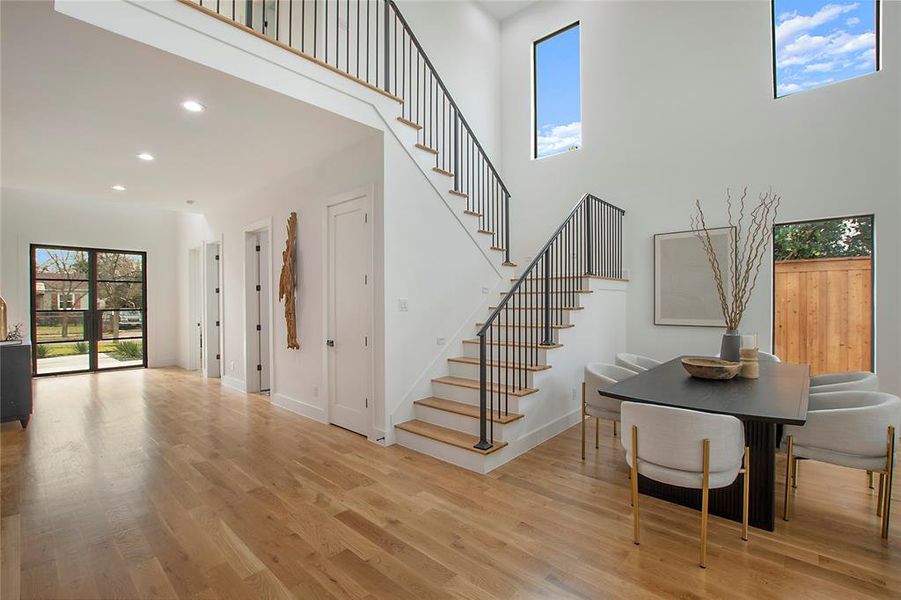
[322,185,376,439]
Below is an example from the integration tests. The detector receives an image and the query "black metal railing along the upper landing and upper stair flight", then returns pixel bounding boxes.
[186,0,510,264]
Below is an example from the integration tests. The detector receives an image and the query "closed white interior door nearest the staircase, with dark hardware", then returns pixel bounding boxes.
[326,195,372,435]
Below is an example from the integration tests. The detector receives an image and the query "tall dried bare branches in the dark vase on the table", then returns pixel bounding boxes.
[691,186,782,331]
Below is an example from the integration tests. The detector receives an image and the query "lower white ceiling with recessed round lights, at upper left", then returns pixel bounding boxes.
[0,2,375,211]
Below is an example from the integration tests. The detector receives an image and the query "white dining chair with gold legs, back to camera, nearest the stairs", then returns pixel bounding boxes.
[620,402,750,567]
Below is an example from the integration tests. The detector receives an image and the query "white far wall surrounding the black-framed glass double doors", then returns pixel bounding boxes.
[0,188,177,367]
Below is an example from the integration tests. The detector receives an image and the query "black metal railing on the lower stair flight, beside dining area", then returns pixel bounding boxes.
[475,194,625,450]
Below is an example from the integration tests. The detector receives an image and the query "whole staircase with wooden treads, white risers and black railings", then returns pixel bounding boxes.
[179,0,626,473]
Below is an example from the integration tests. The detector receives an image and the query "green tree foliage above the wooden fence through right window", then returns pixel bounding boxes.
[773,218,873,260]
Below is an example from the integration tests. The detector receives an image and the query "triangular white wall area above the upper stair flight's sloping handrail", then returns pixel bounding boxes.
[397,0,502,159]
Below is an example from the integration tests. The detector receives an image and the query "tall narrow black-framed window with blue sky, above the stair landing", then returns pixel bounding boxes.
[534,23,582,158]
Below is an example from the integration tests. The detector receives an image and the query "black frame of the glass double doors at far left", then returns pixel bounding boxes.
[28,242,150,377]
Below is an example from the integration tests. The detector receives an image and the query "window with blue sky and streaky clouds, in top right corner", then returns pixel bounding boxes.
[773,0,879,97]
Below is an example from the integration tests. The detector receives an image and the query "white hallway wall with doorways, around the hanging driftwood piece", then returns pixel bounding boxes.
[178,133,383,421]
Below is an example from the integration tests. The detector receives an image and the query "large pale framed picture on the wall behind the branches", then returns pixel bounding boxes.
[654,227,734,327]
